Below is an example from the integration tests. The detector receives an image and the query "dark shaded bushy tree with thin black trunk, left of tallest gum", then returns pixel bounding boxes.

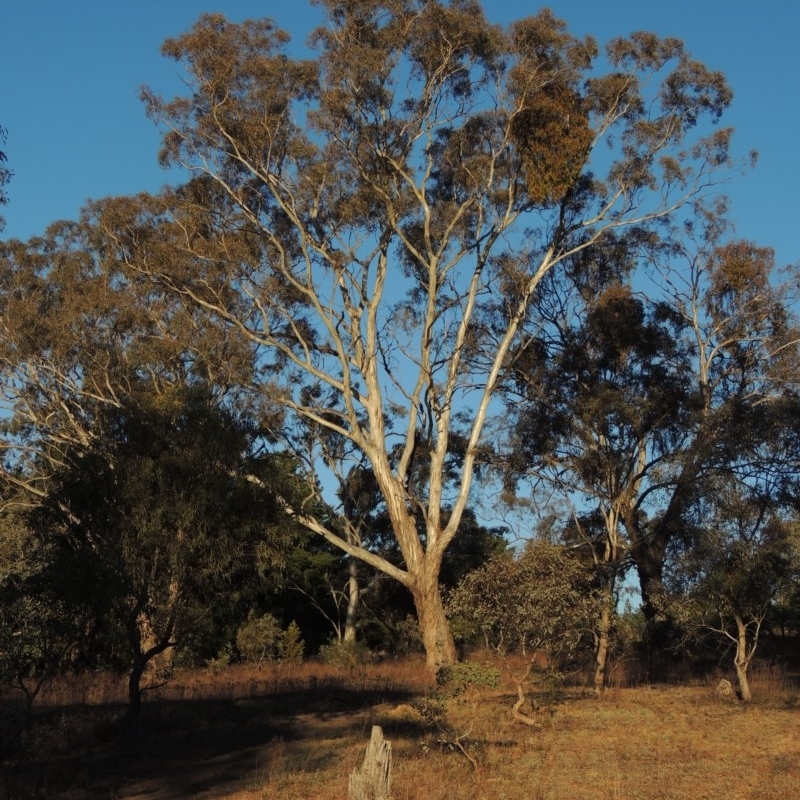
[33,387,297,732]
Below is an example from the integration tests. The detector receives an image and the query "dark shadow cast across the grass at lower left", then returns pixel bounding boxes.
[0,682,424,800]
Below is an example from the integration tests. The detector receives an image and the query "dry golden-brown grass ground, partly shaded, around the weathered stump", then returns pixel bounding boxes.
[2,661,800,800]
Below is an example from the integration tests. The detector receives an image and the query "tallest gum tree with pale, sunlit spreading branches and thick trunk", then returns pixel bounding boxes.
[108,0,731,666]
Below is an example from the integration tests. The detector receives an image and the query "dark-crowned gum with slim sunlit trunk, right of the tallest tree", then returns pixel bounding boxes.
[504,272,690,693]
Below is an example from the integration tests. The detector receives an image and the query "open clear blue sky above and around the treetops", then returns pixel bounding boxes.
[0,0,800,263]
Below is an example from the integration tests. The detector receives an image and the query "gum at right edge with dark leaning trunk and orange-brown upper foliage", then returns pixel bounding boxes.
[626,208,800,617]
